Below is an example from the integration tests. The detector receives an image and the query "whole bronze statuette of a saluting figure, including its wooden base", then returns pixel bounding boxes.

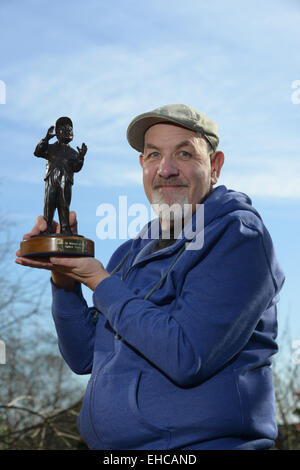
[20,117,94,258]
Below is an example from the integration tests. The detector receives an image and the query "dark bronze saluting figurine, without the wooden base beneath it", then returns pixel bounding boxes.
[34,117,87,234]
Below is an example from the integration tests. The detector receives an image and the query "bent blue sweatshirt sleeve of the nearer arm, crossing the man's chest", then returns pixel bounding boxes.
[93,219,275,386]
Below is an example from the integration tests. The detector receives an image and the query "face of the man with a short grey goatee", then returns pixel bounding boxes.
[140,123,224,218]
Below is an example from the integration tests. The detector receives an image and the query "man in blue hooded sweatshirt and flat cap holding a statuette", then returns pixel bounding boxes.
[17,105,284,450]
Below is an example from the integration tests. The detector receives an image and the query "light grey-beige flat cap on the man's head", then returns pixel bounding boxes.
[127,104,219,152]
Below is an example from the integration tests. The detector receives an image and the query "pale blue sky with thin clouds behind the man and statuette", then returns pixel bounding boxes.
[0,0,300,356]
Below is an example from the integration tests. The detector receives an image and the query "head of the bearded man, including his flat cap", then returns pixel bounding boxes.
[127,105,224,226]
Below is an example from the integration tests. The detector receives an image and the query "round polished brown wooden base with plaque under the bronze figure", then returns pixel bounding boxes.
[20,234,94,258]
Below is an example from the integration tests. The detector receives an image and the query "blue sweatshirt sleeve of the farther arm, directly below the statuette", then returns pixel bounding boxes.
[51,281,111,374]
